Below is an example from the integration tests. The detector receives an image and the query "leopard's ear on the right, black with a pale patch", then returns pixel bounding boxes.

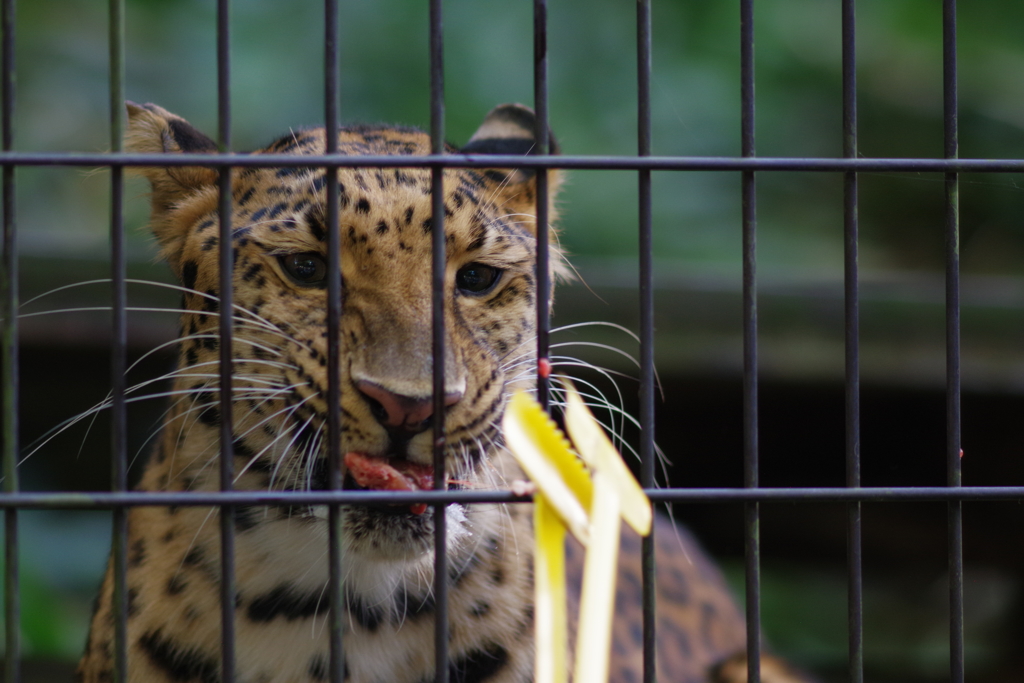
[460,104,561,233]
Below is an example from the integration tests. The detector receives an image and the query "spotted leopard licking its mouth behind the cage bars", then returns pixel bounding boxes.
[76,102,805,683]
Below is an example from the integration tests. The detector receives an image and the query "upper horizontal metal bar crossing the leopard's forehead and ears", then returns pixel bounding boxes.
[6,152,1024,173]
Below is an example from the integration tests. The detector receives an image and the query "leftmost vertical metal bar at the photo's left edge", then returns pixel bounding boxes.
[0,0,22,683]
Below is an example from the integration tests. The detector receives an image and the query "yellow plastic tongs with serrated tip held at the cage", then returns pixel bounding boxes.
[504,380,651,683]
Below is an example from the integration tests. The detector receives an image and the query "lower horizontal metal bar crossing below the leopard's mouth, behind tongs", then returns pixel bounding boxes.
[0,486,1024,510]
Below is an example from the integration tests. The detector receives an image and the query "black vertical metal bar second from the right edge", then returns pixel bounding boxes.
[843,0,864,683]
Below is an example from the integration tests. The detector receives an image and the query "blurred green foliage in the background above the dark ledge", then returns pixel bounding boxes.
[16,0,1024,274]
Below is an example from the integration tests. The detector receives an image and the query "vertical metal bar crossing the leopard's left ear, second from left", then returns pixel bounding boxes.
[109,0,128,683]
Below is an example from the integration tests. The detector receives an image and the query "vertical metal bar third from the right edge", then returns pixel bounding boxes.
[739,0,761,683]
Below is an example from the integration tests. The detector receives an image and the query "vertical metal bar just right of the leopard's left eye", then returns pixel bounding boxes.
[324,0,345,683]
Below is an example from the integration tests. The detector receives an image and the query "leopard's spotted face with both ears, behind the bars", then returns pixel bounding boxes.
[128,104,565,560]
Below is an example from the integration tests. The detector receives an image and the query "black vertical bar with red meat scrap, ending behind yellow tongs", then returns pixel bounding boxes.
[532,0,551,410]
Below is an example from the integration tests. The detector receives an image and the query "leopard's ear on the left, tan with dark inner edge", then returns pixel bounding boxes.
[125,102,217,263]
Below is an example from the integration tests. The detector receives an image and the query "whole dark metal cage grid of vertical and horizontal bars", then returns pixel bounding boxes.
[0,0,1024,683]
